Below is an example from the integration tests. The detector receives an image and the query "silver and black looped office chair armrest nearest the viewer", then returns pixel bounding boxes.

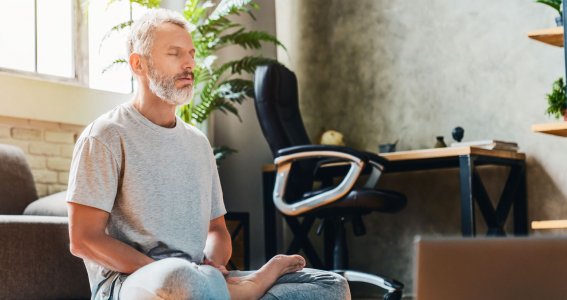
[273,145,367,216]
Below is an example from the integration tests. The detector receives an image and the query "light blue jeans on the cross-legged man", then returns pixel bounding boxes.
[113,258,350,300]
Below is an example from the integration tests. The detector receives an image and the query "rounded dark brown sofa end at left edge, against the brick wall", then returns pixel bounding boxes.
[0,144,37,215]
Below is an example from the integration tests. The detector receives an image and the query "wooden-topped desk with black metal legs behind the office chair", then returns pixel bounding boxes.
[263,147,528,257]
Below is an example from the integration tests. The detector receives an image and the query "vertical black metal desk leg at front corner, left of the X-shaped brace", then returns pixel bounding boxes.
[459,155,476,237]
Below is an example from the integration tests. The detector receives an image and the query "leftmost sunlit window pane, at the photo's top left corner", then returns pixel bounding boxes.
[0,0,35,72]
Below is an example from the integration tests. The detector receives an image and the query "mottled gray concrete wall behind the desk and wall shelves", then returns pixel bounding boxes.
[276,0,567,292]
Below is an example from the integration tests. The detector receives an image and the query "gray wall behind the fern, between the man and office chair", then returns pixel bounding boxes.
[212,0,276,268]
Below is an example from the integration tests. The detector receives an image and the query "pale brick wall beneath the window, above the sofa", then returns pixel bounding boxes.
[0,116,84,197]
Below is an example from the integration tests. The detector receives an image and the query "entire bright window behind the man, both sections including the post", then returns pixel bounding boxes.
[0,0,151,93]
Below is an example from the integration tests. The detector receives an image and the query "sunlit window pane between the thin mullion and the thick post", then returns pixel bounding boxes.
[37,0,75,77]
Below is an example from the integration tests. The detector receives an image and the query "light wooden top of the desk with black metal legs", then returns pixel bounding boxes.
[380,146,526,161]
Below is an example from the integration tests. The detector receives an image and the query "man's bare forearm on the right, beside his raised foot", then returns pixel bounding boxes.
[204,216,232,266]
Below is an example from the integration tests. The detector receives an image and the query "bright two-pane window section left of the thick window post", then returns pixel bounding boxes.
[0,0,75,78]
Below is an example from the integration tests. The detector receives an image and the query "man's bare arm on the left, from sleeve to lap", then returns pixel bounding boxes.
[68,202,154,274]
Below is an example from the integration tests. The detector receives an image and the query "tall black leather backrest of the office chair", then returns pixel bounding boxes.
[254,64,311,157]
